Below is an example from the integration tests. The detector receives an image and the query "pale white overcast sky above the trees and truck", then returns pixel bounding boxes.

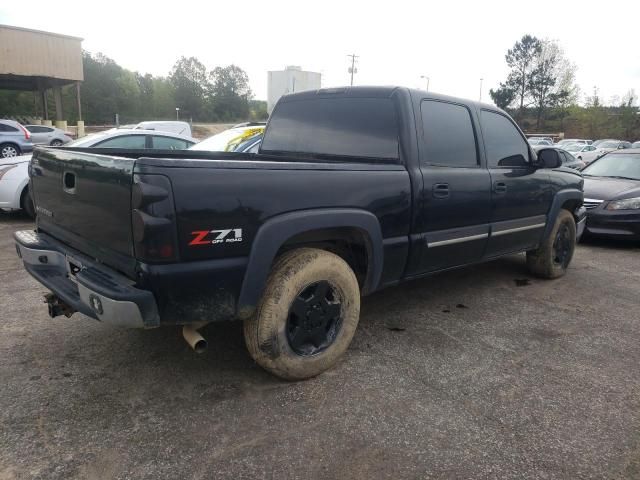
[0,0,640,102]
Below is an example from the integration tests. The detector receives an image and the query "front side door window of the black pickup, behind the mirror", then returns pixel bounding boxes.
[480,110,529,168]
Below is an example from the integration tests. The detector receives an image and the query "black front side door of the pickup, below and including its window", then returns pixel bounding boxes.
[480,109,552,257]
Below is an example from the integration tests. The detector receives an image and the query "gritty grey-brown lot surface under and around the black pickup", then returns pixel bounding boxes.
[0,215,640,479]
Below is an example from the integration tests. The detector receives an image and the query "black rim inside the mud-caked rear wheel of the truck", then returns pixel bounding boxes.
[286,280,342,356]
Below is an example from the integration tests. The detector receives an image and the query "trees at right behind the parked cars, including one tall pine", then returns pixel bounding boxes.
[489,35,640,141]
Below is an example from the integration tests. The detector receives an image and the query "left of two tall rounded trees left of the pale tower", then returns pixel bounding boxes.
[169,57,210,118]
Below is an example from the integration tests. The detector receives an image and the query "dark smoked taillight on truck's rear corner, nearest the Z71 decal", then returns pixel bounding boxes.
[131,175,178,262]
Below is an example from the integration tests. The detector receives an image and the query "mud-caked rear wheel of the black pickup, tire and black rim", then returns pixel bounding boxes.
[244,248,360,380]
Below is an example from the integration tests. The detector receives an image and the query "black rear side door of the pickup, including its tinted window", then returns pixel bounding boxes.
[408,98,491,275]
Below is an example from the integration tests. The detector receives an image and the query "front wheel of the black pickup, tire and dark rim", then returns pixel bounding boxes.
[527,210,576,278]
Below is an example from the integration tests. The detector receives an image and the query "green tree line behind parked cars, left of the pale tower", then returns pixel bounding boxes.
[0,51,267,125]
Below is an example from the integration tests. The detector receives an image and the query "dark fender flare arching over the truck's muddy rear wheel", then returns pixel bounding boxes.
[237,208,384,319]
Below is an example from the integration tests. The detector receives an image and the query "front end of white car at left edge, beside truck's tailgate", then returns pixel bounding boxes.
[0,154,35,218]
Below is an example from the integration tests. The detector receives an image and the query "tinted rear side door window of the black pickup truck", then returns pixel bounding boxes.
[420,100,478,167]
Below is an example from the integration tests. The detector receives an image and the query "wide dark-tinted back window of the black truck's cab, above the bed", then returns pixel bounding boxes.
[261,97,399,159]
